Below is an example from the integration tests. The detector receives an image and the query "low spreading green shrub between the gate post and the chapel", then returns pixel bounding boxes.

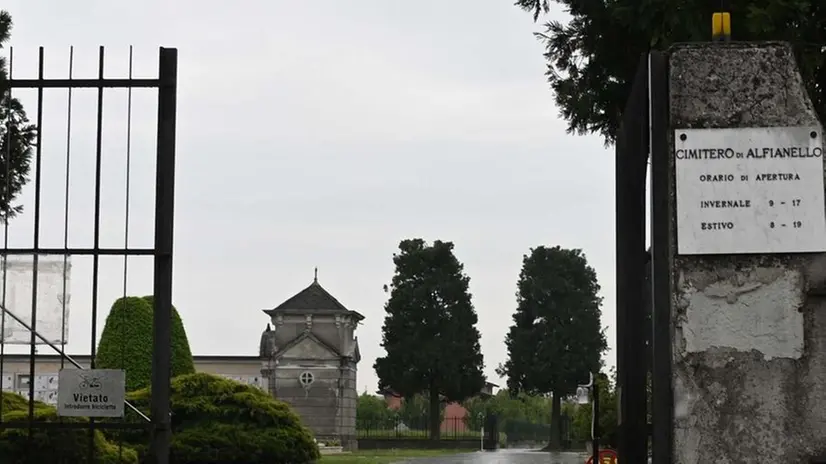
[128,373,319,464]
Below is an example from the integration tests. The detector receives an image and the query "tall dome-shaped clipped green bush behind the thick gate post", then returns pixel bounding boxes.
[95,296,195,391]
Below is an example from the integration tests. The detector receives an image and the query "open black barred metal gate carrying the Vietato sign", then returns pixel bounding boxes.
[0,47,177,464]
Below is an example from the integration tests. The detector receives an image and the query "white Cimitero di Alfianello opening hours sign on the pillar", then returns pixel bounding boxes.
[674,127,826,255]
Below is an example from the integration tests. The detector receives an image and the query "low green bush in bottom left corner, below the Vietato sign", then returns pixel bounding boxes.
[0,392,138,464]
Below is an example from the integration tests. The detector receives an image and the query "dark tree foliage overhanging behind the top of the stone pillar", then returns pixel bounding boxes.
[516,0,826,143]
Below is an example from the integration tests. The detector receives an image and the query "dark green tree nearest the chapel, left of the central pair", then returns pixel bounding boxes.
[373,239,485,439]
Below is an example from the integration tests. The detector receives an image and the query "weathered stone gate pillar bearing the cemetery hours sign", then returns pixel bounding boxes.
[668,43,826,464]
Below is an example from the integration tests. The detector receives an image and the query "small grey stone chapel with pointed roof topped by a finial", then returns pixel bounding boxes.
[260,273,364,450]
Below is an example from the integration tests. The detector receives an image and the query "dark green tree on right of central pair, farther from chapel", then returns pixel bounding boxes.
[497,246,607,449]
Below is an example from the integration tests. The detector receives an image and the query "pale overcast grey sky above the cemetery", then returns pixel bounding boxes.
[3,0,615,391]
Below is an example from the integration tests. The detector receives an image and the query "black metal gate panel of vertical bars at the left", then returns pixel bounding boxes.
[0,47,177,464]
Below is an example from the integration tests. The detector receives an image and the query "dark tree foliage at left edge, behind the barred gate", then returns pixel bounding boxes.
[0,11,37,221]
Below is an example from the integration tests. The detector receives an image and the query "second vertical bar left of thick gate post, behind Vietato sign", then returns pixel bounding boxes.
[89,46,104,462]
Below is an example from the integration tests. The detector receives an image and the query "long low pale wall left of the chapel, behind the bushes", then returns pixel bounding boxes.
[0,354,269,404]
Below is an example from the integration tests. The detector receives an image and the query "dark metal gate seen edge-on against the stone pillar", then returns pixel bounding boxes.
[615,51,673,464]
